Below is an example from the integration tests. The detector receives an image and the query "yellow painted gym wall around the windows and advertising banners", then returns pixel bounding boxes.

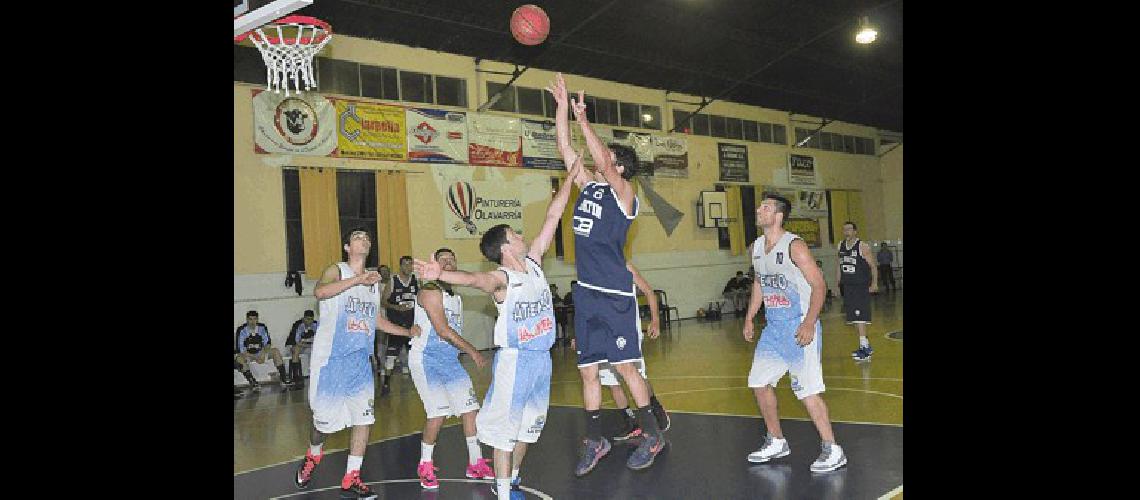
[234,35,902,274]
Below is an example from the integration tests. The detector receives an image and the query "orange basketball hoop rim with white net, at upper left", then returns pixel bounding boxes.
[234,16,333,97]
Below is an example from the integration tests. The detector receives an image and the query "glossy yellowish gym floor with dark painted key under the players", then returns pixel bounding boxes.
[234,292,903,499]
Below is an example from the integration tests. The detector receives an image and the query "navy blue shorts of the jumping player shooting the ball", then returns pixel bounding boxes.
[573,284,642,368]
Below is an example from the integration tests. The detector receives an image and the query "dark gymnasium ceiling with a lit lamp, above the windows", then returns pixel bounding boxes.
[296,0,903,132]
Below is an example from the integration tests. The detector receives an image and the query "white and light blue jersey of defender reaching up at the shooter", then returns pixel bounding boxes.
[495,256,556,351]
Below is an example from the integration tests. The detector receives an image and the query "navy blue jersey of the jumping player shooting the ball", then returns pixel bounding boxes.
[573,182,638,295]
